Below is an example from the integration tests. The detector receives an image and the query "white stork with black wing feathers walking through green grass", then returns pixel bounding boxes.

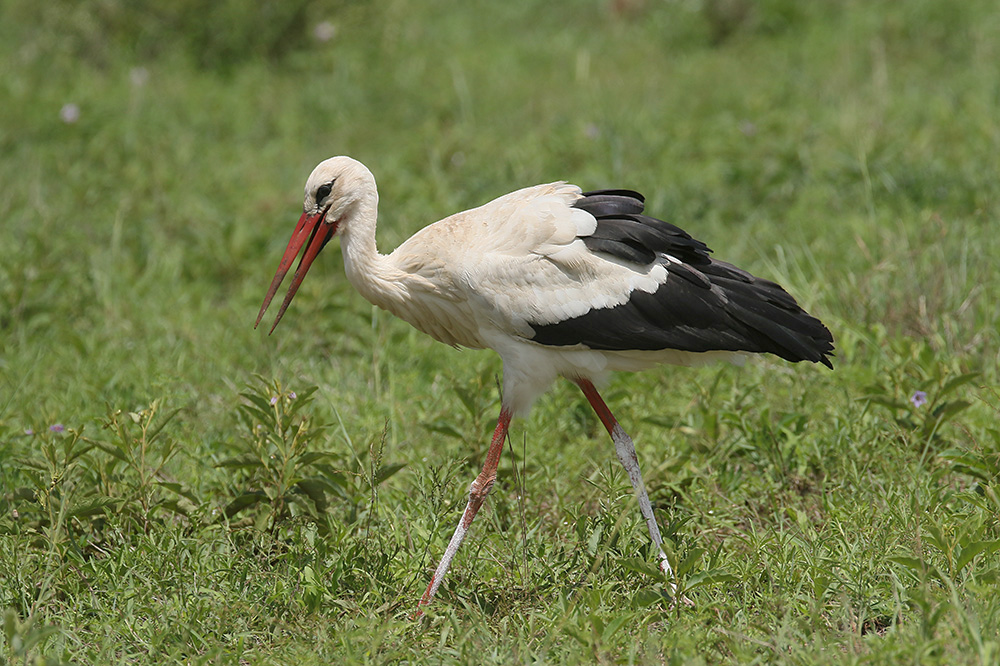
[255,156,834,616]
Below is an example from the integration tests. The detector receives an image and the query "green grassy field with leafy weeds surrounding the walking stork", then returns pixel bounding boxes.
[0,0,1000,665]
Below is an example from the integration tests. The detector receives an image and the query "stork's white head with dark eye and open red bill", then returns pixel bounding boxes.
[254,157,377,332]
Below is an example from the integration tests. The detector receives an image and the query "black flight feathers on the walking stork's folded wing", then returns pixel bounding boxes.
[532,190,833,367]
